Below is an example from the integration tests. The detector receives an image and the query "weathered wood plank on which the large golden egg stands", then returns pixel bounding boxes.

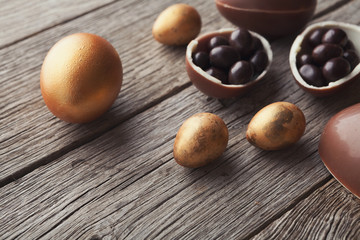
[0,0,230,182]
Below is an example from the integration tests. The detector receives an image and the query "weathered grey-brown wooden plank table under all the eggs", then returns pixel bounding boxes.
[0,0,360,240]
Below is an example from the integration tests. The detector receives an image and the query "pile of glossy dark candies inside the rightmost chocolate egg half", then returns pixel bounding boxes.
[296,22,359,87]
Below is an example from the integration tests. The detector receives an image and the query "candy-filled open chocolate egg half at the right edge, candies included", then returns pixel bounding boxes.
[289,21,360,97]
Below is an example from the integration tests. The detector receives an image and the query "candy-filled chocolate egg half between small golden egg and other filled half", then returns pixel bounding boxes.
[185,28,273,99]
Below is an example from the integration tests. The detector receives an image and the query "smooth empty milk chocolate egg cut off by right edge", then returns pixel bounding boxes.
[319,104,360,198]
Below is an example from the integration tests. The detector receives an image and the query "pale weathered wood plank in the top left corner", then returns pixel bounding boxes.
[0,0,113,49]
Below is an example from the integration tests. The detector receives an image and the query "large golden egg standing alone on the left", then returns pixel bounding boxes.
[40,33,123,123]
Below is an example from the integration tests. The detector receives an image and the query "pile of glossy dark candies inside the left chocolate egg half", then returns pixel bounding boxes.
[193,28,269,84]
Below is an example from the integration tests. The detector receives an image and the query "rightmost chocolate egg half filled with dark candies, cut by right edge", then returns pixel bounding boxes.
[289,21,360,96]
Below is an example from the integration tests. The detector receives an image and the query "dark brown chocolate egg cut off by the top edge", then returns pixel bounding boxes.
[215,0,316,38]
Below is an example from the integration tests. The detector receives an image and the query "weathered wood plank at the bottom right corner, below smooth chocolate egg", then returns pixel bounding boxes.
[253,179,360,240]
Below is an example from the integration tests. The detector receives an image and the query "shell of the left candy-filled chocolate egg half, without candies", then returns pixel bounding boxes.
[185,28,273,98]
